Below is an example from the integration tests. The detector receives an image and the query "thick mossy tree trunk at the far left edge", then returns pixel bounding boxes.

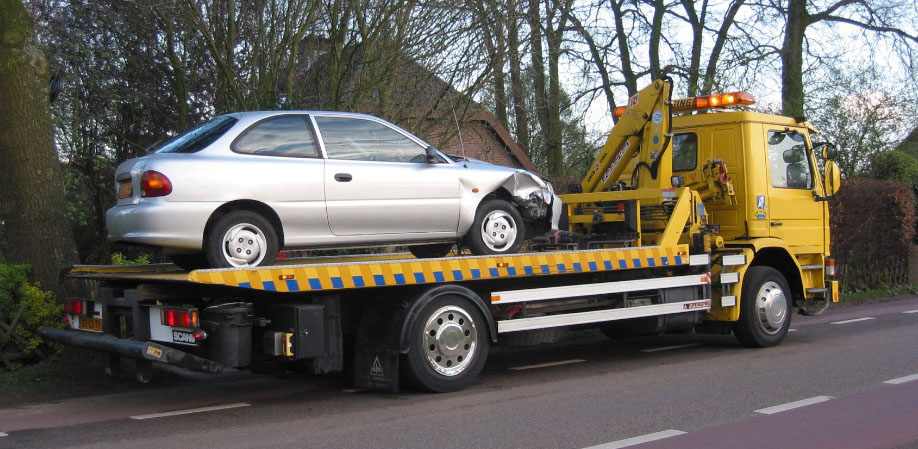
[0,0,78,298]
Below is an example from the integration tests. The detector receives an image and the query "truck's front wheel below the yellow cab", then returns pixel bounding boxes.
[733,266,792,348]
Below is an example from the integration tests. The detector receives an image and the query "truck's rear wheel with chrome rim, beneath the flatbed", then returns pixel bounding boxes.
[403,295,489,393]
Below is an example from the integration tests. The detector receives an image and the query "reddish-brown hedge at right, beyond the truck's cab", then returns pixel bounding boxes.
[829,179,916,292]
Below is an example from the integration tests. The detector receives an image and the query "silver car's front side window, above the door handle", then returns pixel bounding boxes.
[315,117,427,162]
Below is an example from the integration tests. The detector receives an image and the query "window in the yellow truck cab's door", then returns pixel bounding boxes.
[768,131,813,189]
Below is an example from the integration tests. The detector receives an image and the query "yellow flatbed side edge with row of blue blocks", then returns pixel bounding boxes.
[186,245,689,292]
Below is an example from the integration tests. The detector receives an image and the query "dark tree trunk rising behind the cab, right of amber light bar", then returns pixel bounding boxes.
[781,0,810,117]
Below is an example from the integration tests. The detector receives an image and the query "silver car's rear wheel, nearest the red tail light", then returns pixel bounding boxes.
[204,211,278,268]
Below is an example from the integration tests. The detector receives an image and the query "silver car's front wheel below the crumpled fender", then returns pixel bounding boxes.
[465,199,526,255]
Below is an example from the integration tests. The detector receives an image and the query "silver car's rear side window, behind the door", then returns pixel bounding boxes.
[232,115,319,157]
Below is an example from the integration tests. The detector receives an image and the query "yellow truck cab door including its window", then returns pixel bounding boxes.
[756,127,825,253]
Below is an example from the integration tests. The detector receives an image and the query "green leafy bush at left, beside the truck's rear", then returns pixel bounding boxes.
[0,262,64,354]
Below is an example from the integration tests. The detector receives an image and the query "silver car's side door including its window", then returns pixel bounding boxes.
[314,115,461,237]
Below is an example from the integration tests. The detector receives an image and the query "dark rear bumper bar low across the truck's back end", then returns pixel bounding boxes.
[41,327,223,374]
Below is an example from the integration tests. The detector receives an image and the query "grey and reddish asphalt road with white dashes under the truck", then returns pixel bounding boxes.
[0,298,918,449]
